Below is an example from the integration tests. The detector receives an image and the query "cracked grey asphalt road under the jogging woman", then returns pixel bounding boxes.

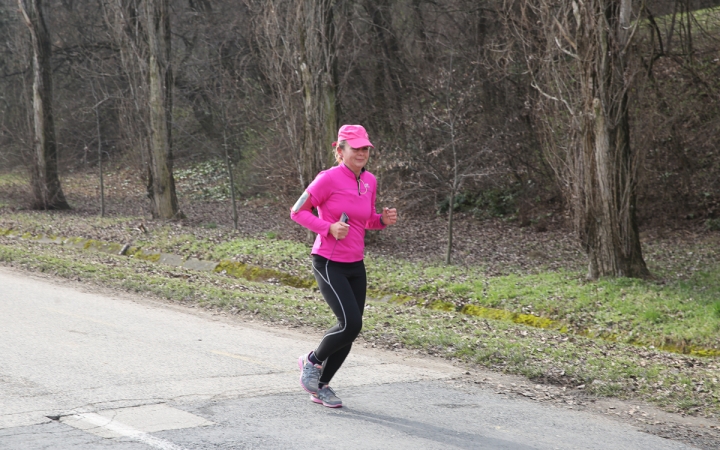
[0,268,690,450]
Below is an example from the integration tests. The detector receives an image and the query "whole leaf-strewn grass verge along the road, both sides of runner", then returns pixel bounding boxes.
[0,209,720,417]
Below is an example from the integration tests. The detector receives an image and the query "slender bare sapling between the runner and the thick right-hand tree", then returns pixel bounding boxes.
[388,2,506,264]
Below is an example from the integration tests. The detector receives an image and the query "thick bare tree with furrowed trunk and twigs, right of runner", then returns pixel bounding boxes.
[509,0,650,279]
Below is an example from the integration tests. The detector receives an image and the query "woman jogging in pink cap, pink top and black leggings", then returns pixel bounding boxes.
[290,125,397,408]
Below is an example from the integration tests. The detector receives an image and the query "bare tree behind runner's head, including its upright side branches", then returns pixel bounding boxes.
[251,0,338,188]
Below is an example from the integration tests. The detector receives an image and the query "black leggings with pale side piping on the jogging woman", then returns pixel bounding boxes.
[312,255,367,384]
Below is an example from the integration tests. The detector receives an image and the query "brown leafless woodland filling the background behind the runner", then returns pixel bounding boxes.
[0,0,720,274]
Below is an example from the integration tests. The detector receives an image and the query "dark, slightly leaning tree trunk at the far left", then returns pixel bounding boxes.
[18,0,70,209]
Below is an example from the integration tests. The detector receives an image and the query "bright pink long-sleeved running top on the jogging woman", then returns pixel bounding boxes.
[290,164,385,262]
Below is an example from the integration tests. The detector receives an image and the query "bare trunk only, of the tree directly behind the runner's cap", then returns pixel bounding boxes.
[297,0,338,187]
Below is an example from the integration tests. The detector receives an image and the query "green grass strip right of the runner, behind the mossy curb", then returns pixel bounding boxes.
[368,255,720,355]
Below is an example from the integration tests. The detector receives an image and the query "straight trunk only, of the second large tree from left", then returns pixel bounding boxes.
[145,0,182,219]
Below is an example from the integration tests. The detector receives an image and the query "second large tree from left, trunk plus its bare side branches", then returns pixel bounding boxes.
[104,0,183,219]
